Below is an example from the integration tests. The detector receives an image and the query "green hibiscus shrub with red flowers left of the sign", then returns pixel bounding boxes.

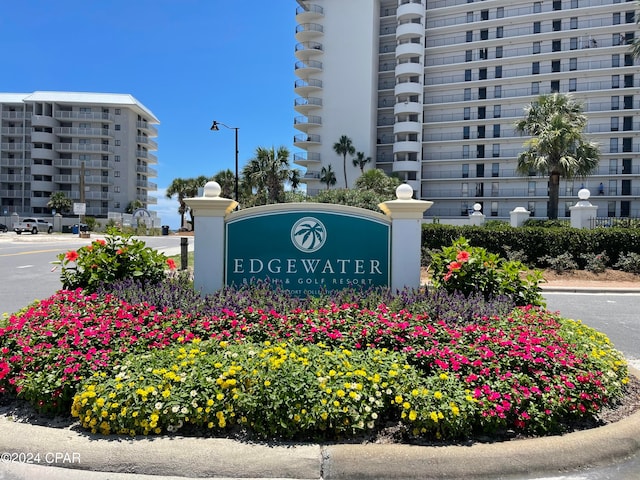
[54,229,175,292]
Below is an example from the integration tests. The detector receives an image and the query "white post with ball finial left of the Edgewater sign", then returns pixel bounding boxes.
[184,182,238,295]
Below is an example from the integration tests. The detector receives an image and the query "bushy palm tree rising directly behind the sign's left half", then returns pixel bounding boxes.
[242,146,292,203]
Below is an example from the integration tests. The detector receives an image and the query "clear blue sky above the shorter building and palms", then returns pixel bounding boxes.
[0,0,297,228]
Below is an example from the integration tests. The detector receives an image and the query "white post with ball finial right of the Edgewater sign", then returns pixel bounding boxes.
[378,184,433,290]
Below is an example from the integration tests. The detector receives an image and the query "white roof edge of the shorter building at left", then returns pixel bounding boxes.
[0,91,160,123]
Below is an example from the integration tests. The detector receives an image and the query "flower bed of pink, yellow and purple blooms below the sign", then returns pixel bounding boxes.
[0,279,628,439]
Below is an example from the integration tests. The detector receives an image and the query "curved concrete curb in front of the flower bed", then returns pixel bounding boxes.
[0,370,640,480]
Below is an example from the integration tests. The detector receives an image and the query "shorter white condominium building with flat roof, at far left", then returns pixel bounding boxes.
[0,92,159,217]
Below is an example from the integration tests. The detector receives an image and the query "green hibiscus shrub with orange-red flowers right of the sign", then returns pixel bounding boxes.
[430,237,544,305]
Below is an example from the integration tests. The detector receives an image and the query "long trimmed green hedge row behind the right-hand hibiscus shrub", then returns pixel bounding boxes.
[422,224,640,268]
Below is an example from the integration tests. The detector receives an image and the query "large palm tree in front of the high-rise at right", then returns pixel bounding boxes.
[515,93,600,219]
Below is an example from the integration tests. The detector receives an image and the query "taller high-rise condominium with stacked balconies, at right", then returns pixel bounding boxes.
[294,0,640,218]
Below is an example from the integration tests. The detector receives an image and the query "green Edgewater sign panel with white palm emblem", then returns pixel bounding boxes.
[225,210,391,296]
